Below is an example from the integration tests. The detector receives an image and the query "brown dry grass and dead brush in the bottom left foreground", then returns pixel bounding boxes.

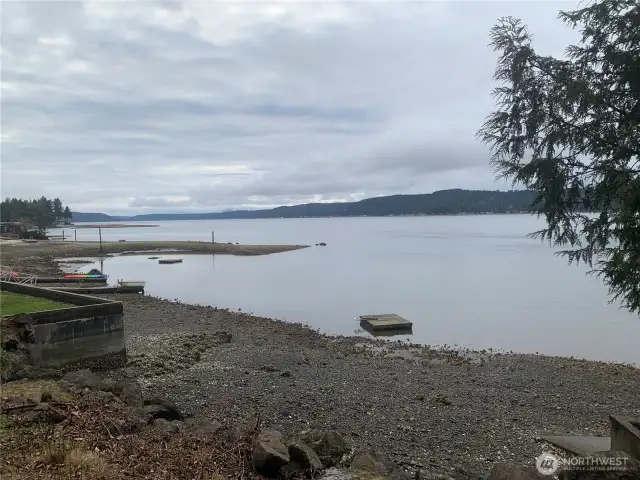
[0,386,270,480]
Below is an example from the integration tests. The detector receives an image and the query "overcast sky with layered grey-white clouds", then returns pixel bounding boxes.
[1,0,577,214]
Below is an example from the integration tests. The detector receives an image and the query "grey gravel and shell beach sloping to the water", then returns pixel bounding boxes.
[110,295,640,478]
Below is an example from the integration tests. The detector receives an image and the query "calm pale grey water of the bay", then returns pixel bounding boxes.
[51,215,640,363]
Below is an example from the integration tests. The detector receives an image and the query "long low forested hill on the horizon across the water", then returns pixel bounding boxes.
[73,189,535,222]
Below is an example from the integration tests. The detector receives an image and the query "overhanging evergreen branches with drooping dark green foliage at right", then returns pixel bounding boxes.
[478,0,640,313]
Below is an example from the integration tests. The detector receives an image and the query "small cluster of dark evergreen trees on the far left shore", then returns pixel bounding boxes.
[0,196,73,234]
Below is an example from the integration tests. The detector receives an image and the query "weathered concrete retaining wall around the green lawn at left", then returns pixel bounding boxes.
[0,282,126,369]
